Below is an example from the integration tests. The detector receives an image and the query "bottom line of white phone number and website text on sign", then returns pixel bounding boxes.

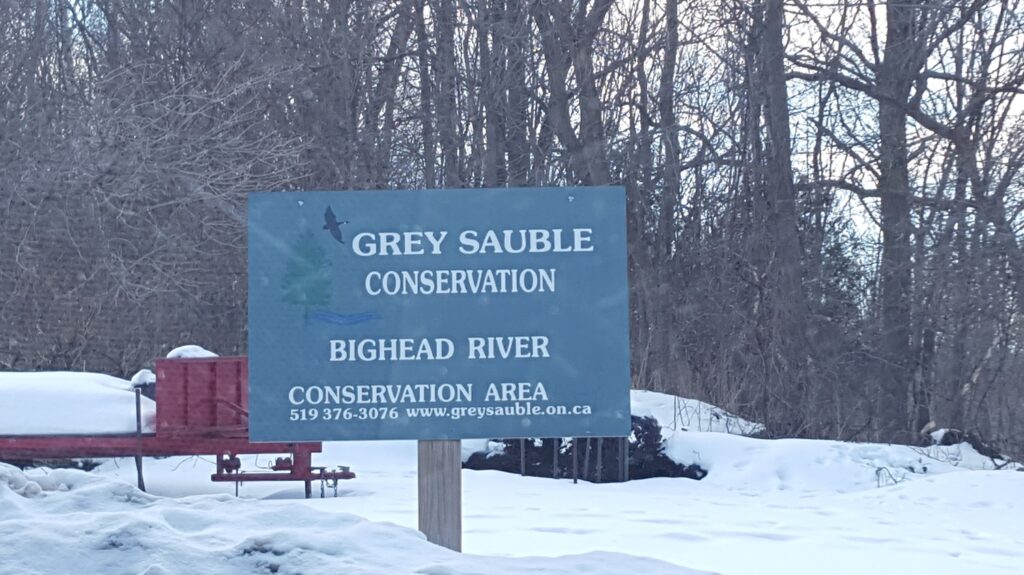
[289,401,593,422]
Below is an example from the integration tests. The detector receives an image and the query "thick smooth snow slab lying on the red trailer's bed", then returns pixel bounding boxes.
[0,371,156,435]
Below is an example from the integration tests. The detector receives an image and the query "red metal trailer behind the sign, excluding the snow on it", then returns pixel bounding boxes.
[0,357,355,497]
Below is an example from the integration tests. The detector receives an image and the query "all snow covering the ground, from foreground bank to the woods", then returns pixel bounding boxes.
[0,374,1024,575]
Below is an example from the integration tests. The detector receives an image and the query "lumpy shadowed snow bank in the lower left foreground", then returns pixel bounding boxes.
[0,465,698,575]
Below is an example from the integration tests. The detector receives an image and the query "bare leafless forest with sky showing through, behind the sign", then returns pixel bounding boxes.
[0,0,1024,456]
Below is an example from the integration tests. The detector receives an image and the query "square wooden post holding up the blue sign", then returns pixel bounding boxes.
[418,439,462,551]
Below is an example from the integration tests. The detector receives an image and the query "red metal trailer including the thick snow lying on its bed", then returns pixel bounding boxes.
[0,357,355,497]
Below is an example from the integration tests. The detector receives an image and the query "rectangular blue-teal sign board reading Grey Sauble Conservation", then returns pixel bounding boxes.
[249,187,630,441]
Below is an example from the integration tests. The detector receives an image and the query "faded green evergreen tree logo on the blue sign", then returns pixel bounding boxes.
[281,230,331,323]
